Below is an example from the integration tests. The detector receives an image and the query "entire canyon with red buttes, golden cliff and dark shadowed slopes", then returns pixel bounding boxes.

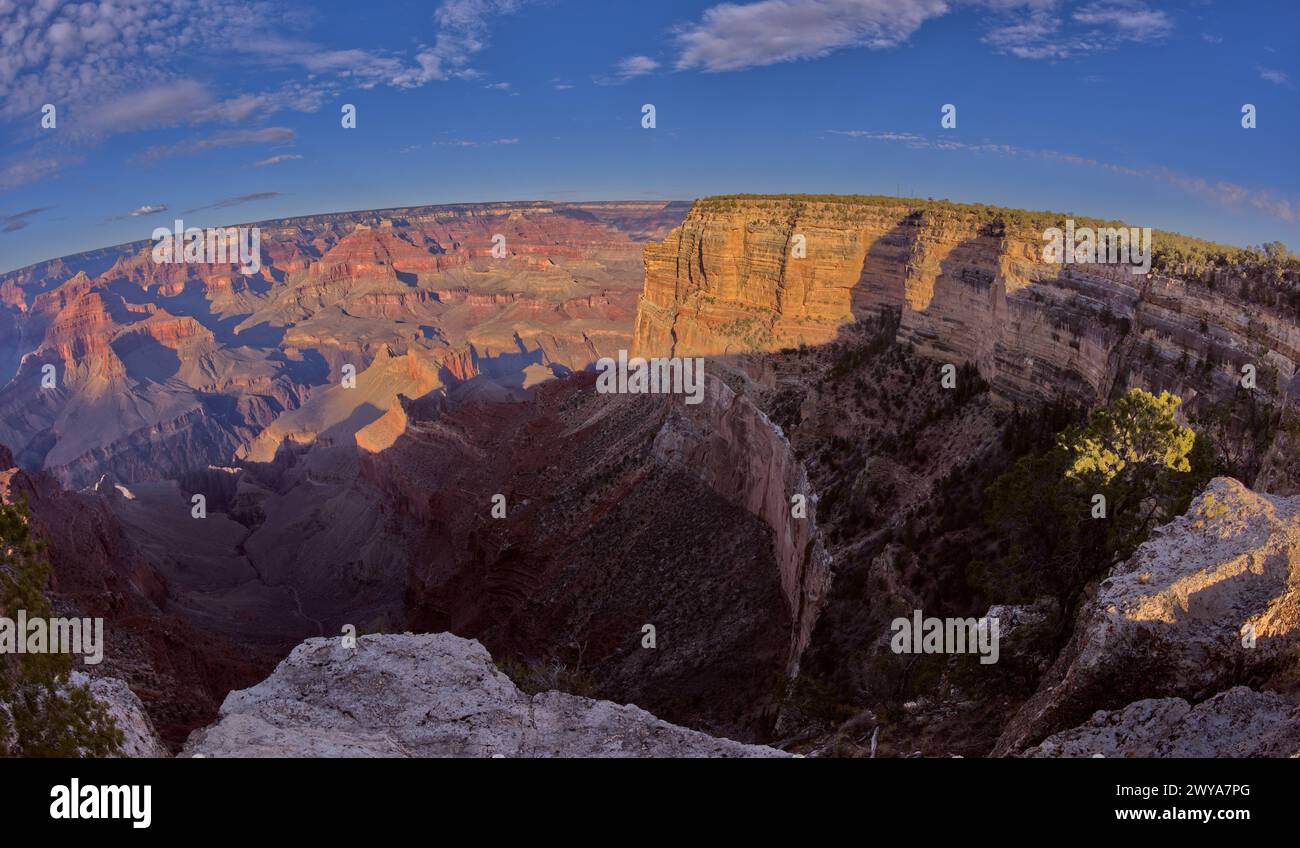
[0,196,1300,756]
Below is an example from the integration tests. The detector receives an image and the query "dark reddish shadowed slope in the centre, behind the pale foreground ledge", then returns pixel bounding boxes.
[361,373,796,739]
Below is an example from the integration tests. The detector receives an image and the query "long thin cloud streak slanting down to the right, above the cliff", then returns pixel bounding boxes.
[827,130,1300,224]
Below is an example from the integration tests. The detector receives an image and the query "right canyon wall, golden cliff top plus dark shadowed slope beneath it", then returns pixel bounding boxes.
[624,196,1300,756]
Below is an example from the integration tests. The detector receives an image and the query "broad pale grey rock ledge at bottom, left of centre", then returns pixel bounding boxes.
[181,633,788,757]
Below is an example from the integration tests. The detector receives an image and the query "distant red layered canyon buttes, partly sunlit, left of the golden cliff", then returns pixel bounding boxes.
[0,203,684,486]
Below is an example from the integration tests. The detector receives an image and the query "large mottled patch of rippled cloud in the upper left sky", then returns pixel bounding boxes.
[0,0,532,190]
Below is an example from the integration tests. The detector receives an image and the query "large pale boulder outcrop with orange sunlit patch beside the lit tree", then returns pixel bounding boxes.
[995,477,1300,754]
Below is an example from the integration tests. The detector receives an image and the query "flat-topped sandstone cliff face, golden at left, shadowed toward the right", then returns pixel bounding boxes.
[634,198,1300,402]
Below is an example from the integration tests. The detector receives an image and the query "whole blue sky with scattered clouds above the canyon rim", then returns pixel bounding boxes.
[0,0,1300,271]
